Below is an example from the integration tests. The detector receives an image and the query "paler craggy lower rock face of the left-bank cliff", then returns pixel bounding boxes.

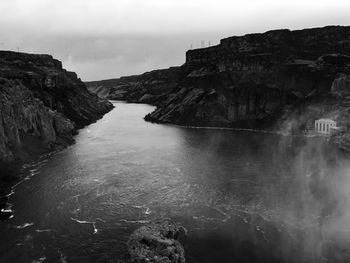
[0,78,75,162]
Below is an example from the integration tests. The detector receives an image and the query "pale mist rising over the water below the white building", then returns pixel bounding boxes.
[253,136,350,262]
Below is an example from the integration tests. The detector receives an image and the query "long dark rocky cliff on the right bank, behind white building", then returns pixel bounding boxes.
[88,26,350,133]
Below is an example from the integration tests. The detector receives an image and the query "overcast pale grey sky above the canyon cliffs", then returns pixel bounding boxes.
[0,0,350,81]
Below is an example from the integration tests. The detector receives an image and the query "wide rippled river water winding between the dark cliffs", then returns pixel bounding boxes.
[0,102,350,263]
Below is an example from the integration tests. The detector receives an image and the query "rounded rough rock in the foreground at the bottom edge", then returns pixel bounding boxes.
[127,221,186,263]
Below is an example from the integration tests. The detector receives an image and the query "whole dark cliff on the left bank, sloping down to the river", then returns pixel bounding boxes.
[0,51,113,163]
